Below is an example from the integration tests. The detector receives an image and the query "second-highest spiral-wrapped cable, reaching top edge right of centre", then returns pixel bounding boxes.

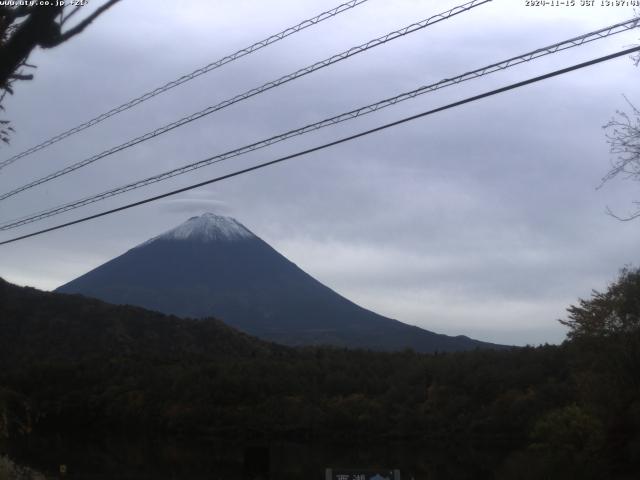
[0,0,492,201]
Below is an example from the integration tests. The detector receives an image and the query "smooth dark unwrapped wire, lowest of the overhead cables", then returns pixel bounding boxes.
[0,47,640,245]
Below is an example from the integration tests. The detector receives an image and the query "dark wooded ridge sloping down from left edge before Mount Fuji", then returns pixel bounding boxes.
[0,279,287,365]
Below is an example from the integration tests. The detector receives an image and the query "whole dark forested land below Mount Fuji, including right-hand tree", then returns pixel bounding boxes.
[0,271,640,479]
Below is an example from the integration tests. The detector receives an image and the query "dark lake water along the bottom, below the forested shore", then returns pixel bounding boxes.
[0,437,510,480]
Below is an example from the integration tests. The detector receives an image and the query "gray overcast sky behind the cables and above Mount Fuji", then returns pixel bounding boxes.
[0,0,640,344]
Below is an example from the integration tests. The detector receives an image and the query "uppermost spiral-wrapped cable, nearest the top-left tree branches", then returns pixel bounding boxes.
[0,0,369,170]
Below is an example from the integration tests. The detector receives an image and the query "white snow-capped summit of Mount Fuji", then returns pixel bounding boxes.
[150,212,254,242]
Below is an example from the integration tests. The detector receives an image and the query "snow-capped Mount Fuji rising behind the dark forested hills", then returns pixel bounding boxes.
[56,213,502,352]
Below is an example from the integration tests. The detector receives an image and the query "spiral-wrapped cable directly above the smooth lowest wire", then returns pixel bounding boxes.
[0,18,640,231]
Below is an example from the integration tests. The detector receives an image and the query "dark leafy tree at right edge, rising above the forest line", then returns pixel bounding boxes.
[562,269,640,478]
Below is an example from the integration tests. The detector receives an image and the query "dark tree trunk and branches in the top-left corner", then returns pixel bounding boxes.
[0,0,120,143]
